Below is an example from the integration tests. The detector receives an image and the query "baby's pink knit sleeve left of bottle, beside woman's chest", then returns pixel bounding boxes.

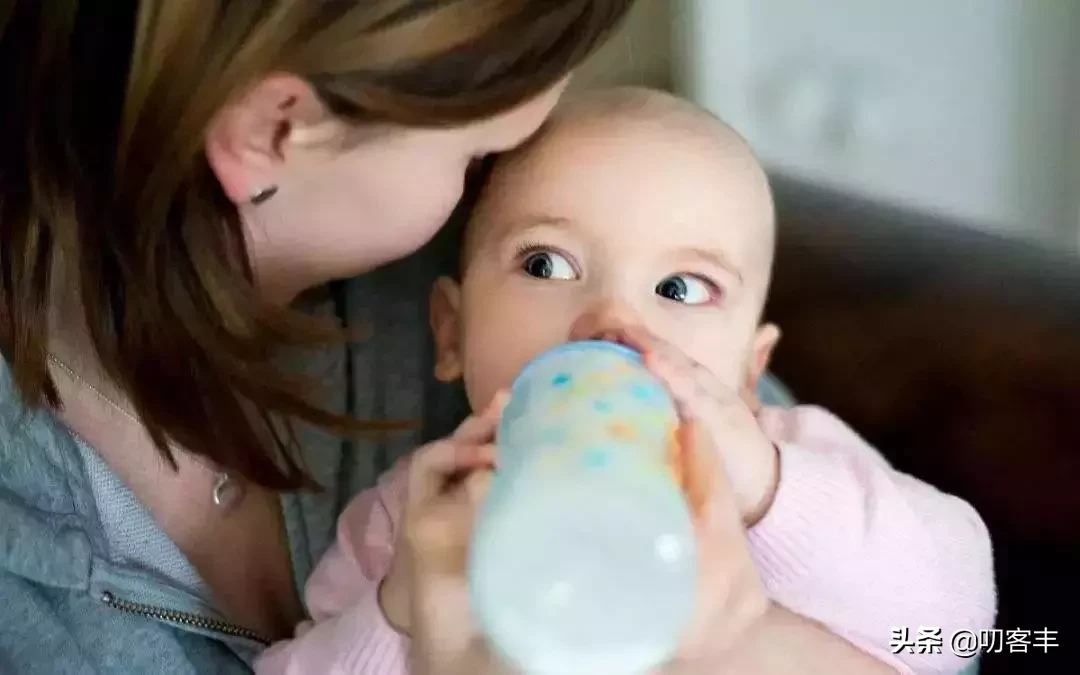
[255,460,408,675]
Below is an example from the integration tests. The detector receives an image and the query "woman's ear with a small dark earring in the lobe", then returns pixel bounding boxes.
[204,75,332,204]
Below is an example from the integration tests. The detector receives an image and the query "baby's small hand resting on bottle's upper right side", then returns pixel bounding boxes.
[629,329,780,527]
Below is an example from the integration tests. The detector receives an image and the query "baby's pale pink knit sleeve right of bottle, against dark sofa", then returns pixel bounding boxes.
[750,406,997,674]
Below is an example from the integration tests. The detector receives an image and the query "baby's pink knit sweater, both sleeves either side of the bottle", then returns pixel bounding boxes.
[255,407,996,675]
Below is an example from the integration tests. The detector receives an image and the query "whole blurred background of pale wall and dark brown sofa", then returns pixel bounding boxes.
[575,0,1080,673]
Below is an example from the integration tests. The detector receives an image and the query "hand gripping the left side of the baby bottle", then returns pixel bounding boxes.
[379,395,514,675]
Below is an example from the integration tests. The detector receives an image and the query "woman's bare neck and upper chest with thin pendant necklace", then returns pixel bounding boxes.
[49,253,302,637]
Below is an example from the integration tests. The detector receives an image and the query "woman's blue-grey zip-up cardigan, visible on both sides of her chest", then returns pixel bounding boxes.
[0,248,785,675]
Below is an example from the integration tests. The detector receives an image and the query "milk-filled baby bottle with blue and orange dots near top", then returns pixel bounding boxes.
[469,341,698,675]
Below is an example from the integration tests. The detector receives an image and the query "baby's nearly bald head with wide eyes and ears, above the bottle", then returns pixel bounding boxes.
[432,104,777,409]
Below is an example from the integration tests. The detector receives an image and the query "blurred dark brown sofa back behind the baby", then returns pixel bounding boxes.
[767,179,1080,675]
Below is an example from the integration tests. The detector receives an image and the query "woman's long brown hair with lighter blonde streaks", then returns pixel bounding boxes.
[0,0,633,489]
